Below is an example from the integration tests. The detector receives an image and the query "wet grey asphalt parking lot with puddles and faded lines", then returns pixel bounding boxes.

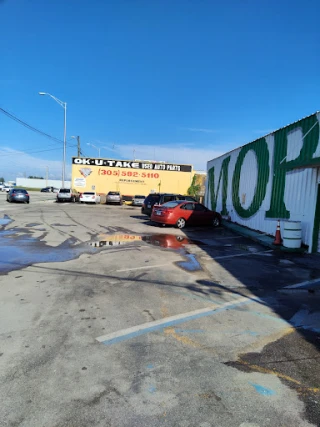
[0,193,320,427]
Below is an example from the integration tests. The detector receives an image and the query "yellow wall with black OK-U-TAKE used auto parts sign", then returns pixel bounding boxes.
[72,157,193,196]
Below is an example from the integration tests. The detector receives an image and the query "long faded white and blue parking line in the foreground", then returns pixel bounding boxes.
[96,297,256,345]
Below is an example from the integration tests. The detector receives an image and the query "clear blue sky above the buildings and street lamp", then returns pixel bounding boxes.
[0,0,320,179]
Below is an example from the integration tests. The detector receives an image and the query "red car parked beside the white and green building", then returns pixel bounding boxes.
[151,200,221,228]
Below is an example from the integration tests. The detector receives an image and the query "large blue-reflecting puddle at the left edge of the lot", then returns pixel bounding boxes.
[0,229,96,273]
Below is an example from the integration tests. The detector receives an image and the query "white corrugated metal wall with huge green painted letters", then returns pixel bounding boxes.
[206,113,320,249]
